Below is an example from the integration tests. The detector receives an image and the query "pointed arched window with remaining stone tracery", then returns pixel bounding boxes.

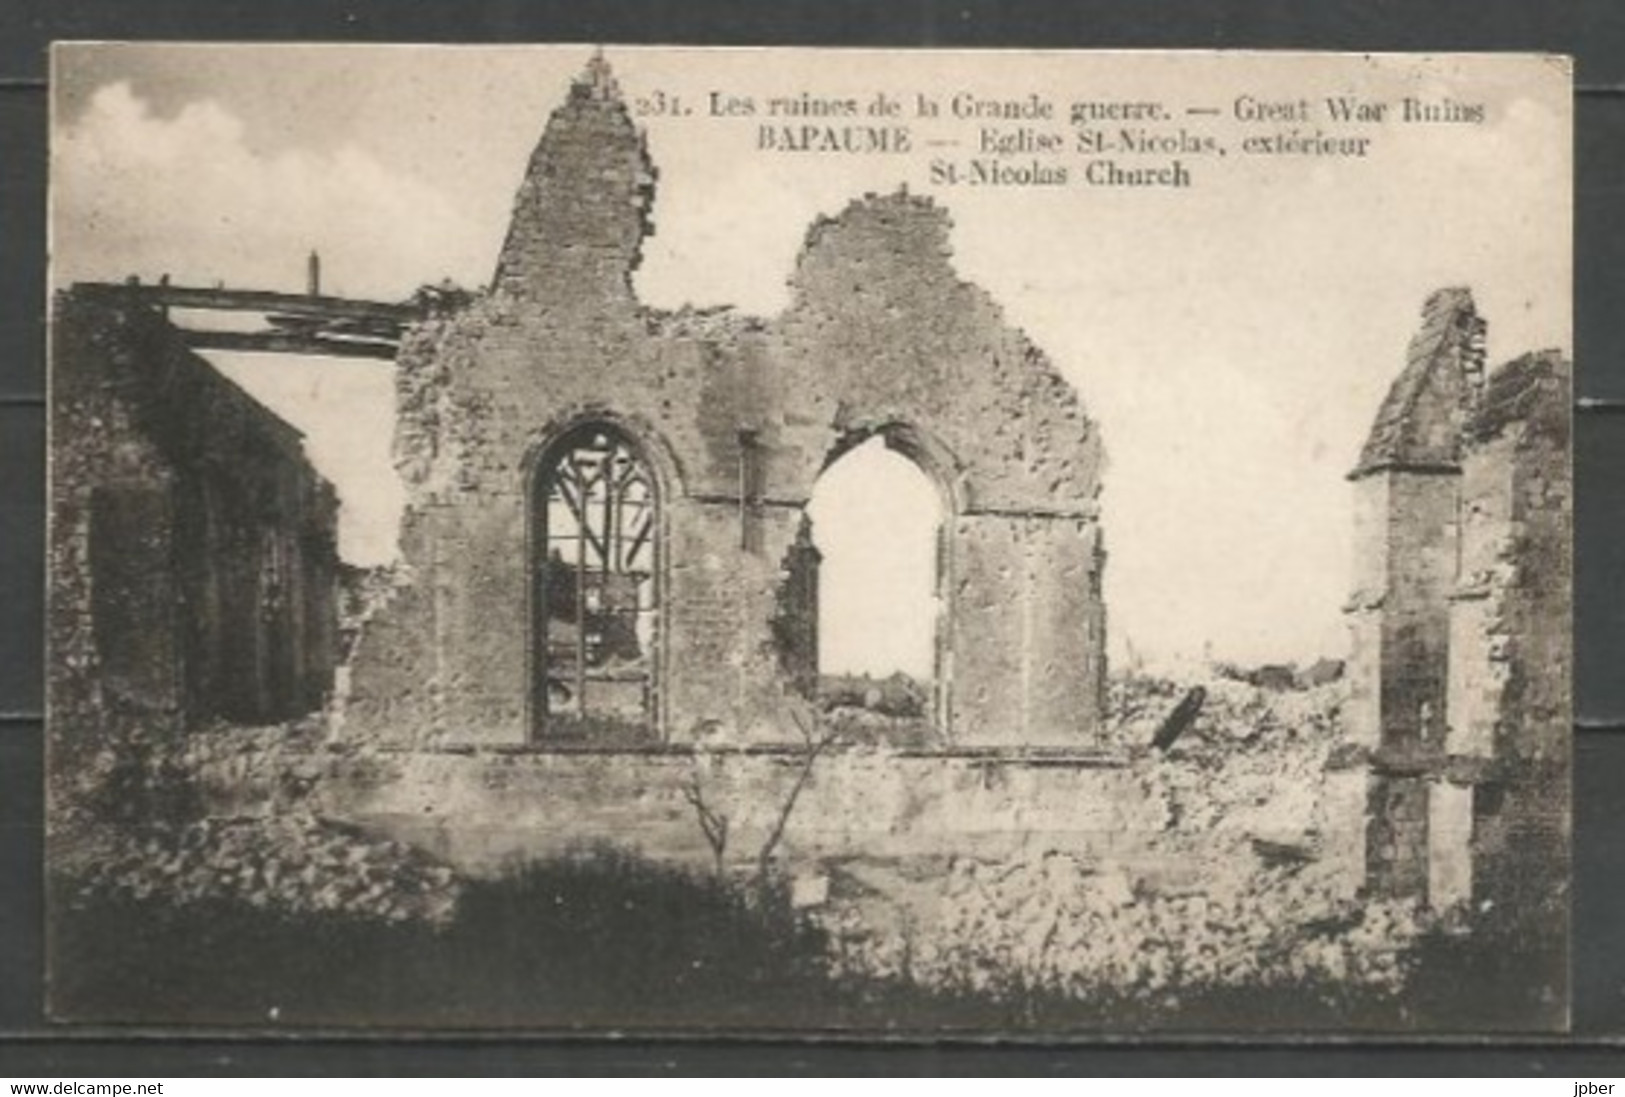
[530,419,665,746]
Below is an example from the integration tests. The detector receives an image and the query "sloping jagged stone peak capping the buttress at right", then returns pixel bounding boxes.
[1349,286,1487,479]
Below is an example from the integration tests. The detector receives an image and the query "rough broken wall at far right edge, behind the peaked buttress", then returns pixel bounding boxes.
[1451,353,1573,923]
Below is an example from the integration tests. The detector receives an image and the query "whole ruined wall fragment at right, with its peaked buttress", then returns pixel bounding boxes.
[1347,288,1571,925]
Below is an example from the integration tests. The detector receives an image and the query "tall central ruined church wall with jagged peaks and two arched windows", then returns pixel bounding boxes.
[345,57,1105,751]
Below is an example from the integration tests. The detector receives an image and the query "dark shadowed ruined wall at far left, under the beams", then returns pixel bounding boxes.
[49,288,338,825]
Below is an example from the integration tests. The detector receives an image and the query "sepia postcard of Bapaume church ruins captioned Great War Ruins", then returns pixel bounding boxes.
[47,44,1571,1037]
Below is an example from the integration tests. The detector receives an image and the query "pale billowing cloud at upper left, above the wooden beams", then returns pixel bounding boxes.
[52,83,494,299]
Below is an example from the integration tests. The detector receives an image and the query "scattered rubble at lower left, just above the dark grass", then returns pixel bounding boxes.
[68,814,462,925]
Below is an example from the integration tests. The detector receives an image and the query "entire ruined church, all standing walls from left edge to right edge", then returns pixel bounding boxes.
[49,59,1571,929]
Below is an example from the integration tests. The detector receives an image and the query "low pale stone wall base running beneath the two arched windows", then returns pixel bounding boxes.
[200,744,1162,874]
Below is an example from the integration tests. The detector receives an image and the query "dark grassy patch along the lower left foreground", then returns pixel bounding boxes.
[50,853,845,1029]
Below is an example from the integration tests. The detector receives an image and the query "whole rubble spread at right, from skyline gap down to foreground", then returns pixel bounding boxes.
[821,674,1432,999]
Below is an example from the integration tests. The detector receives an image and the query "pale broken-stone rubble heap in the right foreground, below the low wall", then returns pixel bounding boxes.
[827,853,1425,998]
